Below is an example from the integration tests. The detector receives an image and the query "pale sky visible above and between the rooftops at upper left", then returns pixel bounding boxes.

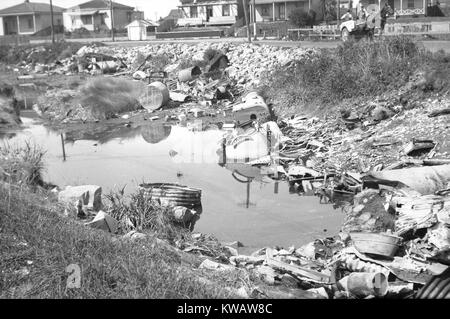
[0,0,180,20]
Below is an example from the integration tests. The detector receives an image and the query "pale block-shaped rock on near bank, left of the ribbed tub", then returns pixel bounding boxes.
[58,185,102,211]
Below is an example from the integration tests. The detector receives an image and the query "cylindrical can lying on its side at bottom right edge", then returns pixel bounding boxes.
[339,272,388,298]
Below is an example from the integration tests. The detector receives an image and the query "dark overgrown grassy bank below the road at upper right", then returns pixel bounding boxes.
[262,37,450,112]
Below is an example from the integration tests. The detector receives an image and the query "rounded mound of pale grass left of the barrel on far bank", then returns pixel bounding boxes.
[80,77,142,119]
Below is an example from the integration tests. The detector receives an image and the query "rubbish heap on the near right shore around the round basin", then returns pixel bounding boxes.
[180,185,450,299]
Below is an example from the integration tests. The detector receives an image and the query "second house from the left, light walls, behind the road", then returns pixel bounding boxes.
[63,0,144,31]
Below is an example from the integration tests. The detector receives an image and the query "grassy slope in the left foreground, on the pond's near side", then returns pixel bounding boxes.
[0,147,243,298]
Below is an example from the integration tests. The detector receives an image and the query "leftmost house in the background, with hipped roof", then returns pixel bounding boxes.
[0,0,64,36]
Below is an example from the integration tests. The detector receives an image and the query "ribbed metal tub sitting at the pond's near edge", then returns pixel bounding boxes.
[139,183,202,208]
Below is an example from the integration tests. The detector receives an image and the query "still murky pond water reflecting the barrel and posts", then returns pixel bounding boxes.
[0,114,343,250]
